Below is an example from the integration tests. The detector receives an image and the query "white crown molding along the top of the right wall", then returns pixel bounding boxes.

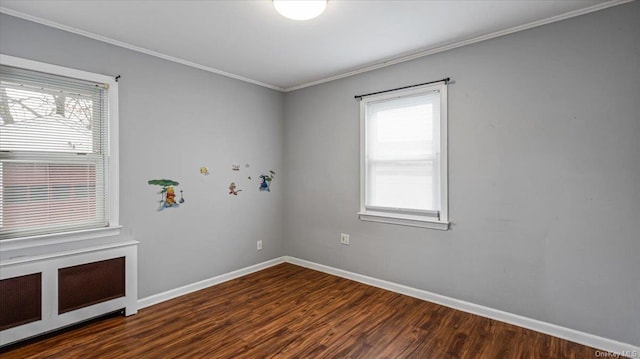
[283,0,634,92]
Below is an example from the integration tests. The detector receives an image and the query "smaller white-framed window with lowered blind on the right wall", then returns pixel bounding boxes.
[359,82,449,230]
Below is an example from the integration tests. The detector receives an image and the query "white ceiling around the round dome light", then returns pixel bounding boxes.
[0,0,627,91]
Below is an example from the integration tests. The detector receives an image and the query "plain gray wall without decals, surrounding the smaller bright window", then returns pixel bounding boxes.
[284,2,640,345]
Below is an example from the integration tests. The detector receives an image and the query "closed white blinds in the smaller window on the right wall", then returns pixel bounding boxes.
[365,91,440,217]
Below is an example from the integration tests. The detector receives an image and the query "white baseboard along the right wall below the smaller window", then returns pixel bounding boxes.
[285,257,640,353]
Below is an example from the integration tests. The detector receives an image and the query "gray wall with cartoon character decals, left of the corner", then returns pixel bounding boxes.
[0,14,284,298]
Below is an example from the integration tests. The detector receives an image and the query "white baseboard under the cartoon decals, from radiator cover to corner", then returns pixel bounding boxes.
[138,257,285,309]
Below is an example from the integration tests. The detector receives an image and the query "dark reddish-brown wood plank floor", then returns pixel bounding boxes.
[0,263,596,359]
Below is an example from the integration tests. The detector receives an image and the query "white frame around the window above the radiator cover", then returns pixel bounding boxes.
[0,54,122,252]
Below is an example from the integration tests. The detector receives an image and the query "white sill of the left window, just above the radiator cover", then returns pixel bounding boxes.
[0,226,122,253]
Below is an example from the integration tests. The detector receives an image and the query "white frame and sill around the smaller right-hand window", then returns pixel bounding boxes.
[358,81,450,231]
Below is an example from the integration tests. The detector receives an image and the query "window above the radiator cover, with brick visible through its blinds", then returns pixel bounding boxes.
[0,55,118,240]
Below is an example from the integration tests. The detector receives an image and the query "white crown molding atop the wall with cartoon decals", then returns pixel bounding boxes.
[0,7,284,91]
